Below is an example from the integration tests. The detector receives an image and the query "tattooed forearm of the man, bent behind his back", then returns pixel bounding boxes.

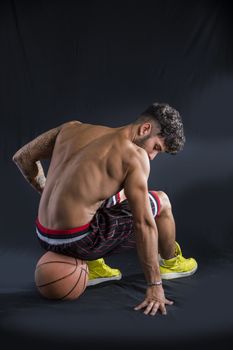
[13,156,46,193]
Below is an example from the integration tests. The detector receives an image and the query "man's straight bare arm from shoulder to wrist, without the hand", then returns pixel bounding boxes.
[124,150,160,283]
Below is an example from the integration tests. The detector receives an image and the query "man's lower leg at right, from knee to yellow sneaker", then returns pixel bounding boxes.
[155,191,197,279]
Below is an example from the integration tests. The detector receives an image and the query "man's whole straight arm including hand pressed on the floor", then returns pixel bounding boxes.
[124,149,171,315]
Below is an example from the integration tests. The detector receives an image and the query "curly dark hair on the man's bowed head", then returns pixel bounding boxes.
[134,103,185,154]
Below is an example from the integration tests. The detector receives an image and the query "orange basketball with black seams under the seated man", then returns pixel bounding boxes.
[35,252,89,300]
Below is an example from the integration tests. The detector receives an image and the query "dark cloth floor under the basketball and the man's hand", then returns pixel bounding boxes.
[0,248,233,349]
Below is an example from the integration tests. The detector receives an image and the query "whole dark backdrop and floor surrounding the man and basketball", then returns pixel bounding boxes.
[0,0,233,348]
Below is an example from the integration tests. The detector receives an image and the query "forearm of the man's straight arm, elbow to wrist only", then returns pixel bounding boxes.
[135,225,161,283]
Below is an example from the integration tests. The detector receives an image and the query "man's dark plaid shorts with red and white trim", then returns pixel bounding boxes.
[36,191,160,260]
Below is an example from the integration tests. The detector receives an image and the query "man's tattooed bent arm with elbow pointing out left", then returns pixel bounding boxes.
[12,121,80,193]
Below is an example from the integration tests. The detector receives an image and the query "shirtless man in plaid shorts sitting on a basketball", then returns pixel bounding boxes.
[13,103,197,315]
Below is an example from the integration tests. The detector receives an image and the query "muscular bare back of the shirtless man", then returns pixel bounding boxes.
[38,122,143,229]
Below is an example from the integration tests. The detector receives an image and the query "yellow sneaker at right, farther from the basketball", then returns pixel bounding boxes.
[159,242,197,280]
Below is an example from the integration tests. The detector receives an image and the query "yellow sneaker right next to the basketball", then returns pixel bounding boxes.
[86,258,122,286]
